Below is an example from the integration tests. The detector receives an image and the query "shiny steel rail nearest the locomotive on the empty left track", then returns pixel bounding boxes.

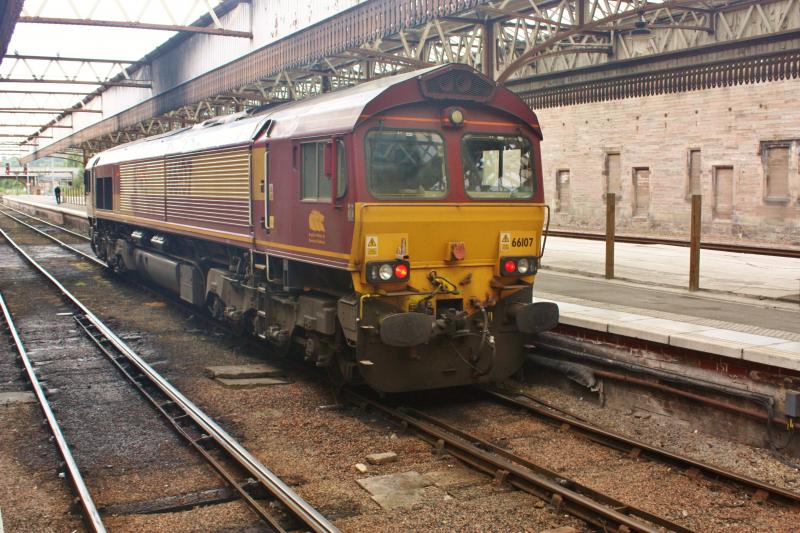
[0,225,338,533]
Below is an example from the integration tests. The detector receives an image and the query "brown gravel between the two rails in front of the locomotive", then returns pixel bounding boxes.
[418,390,797,532]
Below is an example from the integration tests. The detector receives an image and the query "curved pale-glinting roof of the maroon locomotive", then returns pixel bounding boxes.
[87,65,535,168]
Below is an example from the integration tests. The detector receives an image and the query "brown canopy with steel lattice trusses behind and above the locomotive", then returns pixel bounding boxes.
[10,0,800,160]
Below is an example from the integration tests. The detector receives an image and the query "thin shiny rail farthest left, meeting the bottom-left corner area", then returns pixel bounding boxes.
[0,294,106,533]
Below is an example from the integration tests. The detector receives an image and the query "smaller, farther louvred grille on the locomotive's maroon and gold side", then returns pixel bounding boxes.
[119,160,164,220]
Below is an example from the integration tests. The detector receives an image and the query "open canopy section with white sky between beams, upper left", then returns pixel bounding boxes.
[0,0,238,162]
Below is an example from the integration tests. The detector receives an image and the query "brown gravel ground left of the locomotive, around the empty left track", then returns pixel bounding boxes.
[0,220,581,533]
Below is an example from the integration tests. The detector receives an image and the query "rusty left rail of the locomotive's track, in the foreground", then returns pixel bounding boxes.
[340,389,692,533]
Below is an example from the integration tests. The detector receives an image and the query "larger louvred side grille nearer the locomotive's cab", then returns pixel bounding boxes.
[165,147,250,227]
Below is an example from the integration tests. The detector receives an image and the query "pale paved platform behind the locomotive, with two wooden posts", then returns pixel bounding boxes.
[3,196,800,370]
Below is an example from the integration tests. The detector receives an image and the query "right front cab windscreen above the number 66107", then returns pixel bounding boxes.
[461,134,534,200]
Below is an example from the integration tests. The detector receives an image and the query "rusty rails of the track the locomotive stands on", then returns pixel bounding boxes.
[3,204,800,531]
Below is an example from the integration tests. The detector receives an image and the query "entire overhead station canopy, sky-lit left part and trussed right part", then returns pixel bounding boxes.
[0,0,788,166]
